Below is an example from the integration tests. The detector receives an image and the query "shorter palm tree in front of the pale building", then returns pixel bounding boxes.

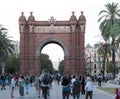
[94,42,111,77]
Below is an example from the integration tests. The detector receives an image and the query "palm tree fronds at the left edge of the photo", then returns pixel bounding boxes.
[0,25,14,62]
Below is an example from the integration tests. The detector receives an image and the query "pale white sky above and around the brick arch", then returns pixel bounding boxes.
[0,0,120,61]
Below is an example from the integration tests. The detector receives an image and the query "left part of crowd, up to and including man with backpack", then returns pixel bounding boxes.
[0,70,53,99]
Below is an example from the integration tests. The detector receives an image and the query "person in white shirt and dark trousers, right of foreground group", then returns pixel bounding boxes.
[85,77,93,99]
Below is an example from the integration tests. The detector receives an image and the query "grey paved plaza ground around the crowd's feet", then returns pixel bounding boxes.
[0,82,119,99]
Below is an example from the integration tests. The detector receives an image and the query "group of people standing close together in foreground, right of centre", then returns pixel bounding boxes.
[61,75,93,99]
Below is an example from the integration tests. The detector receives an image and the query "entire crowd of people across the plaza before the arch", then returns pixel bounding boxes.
[0,69,112,99]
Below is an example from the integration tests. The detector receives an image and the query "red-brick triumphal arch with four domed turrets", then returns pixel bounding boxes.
[18,12,86,75]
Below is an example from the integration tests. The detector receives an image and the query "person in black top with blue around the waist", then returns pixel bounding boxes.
[61,76,71,99]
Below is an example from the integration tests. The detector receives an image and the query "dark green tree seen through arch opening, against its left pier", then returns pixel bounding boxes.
[40,53,53,73]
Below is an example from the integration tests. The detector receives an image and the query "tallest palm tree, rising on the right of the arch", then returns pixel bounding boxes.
[98,2,120,79]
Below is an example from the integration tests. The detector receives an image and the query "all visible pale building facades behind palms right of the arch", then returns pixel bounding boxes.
[85,44,120,76]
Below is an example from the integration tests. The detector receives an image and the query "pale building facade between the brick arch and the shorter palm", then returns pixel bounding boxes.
[85,44,102,76]
